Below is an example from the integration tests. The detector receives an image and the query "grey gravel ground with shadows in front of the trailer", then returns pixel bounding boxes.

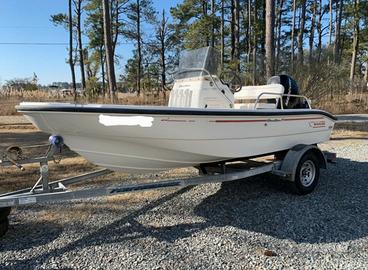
[0,137,368,270]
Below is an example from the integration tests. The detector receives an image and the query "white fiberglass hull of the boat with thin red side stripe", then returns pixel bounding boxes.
[18,103,334,172]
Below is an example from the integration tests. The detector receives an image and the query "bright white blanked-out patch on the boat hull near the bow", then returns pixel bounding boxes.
[98,114,154,127]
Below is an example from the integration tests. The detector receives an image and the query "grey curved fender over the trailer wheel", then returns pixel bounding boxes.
[280,144,327,182]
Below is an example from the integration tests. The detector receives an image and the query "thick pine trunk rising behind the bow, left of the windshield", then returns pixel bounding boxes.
[102,0,116,103]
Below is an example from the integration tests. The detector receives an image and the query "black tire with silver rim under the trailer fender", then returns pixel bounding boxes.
[294,151,320,195]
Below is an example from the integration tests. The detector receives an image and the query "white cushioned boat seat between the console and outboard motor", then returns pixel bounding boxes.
[234,84,284,110]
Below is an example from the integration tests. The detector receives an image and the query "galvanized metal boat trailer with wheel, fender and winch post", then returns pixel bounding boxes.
[0,136,336,237]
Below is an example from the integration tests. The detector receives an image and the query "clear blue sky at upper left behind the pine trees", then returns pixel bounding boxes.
[0,0,180,85]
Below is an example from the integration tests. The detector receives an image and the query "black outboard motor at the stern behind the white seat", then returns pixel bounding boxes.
[267,74,308,109]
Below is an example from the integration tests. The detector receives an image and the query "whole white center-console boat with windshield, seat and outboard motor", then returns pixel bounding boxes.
[17,47,336,173]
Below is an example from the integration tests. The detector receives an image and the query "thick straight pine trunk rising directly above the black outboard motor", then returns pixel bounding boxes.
[266,0,275,78]
